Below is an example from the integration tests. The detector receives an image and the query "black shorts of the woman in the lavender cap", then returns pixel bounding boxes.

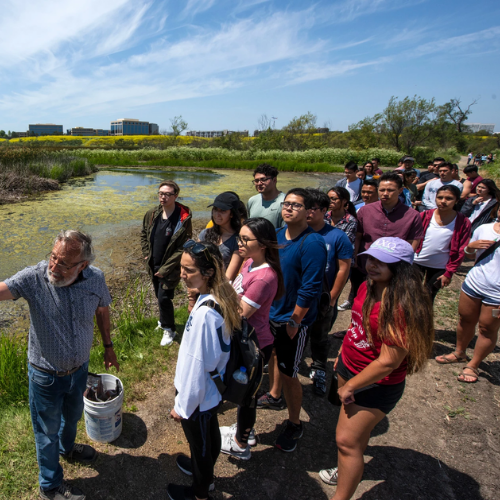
[336,355,405,414]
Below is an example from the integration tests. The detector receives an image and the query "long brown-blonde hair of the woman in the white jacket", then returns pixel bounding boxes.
[184,241,241,338]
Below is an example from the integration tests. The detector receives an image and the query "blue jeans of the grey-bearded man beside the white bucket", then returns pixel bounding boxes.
[28,362,88,490]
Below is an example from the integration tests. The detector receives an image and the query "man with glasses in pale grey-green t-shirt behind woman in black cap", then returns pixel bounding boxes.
[247,163,285,228]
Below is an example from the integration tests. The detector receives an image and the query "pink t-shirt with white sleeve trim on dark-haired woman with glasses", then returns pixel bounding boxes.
[233,259,278,349]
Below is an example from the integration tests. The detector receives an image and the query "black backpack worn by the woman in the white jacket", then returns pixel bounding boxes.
[202,300,264,408]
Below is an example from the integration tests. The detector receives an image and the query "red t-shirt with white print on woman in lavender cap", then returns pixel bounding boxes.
[342,281,408,385]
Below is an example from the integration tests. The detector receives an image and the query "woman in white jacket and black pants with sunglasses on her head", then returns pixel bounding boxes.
[167,240,241,500]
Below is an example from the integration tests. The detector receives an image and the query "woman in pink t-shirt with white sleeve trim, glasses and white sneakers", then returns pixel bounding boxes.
[220,217,285,460]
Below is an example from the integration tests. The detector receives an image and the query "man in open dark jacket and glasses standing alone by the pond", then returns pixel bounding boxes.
[141,181,193,346]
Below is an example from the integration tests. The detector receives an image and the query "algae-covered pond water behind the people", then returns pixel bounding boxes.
[0,168,340,281]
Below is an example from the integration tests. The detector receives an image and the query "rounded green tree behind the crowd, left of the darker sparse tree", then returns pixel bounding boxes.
[380,95,437,154]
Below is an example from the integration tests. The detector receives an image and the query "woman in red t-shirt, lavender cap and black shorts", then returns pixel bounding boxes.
[320,238,434,500]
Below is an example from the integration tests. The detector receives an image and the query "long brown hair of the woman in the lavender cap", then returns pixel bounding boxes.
[363,261,434,375]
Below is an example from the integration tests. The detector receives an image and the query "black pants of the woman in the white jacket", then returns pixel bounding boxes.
[181,406,221,498]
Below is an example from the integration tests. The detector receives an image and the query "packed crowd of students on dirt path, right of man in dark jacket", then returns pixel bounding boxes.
[154,161,500,500]
